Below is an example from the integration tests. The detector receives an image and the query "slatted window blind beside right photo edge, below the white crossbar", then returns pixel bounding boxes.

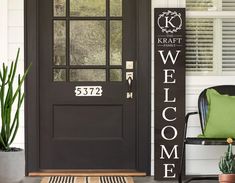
[222,19,235,72]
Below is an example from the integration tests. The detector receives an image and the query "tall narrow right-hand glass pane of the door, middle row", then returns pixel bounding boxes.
[110,21,122,65]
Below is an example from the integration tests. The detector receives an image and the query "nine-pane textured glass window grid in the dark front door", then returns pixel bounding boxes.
[53,0,124,82]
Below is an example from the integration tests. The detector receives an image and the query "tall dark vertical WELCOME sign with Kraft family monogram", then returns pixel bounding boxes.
[154,8,185,180]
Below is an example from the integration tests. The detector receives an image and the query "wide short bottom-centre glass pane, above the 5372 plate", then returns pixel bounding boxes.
[70,69,106,81]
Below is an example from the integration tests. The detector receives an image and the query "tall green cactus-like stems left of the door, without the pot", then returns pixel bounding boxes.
[0,49,32,150]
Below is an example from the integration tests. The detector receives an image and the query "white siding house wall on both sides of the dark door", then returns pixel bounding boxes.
[0,0,235,177]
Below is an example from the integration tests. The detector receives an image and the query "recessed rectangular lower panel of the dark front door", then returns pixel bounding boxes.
[53,105,123,140]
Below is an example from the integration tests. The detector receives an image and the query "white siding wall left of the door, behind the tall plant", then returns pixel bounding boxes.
[0,0,24,148]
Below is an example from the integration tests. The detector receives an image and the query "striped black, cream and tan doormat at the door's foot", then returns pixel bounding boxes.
[41,176,134,183]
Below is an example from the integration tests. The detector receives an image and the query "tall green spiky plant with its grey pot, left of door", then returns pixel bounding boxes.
[0,49,31,183]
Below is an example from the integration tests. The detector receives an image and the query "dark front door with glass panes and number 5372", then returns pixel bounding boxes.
[26,0,150,172]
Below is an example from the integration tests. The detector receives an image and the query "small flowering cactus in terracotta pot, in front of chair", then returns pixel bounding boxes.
[219,138,235,183]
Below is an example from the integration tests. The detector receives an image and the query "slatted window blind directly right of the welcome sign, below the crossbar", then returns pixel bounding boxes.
[186,18,213,72]
